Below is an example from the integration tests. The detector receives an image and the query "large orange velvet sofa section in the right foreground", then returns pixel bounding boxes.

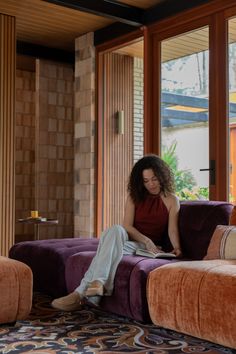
[147,259,236,349]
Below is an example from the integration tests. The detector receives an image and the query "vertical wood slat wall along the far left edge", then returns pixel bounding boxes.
[0,14,16,256]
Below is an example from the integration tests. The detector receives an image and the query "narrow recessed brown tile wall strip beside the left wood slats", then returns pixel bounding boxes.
[15,70,35,241]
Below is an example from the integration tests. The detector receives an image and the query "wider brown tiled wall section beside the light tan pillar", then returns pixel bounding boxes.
[35,60,74,239]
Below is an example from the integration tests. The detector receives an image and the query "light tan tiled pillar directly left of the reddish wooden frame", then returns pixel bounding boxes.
[74,33,95,237]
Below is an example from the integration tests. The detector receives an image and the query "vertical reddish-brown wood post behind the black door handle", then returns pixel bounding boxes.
[209,13,228,200]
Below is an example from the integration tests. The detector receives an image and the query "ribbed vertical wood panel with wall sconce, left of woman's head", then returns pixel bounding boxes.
[102,53,133,228]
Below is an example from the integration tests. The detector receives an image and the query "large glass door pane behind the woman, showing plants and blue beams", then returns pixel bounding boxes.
[161,27,209,200]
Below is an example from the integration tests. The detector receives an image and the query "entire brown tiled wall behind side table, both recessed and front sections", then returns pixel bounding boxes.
[15,60,74,242]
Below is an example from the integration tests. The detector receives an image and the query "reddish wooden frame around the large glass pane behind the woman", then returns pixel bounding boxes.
[145,0,236,200]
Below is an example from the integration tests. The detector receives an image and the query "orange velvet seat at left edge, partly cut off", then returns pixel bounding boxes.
[0,256,33,324]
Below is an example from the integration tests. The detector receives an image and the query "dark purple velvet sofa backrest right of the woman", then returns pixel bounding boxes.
[179,200,233,260]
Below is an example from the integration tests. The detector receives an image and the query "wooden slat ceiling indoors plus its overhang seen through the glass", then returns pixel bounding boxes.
[0,0,236,61]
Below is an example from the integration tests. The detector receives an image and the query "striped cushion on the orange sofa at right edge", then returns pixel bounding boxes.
[204,225,236,260]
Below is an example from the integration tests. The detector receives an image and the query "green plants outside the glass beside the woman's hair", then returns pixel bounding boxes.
[162,141,209,200]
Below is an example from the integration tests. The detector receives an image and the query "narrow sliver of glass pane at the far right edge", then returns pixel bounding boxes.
[228,18,236,202]
